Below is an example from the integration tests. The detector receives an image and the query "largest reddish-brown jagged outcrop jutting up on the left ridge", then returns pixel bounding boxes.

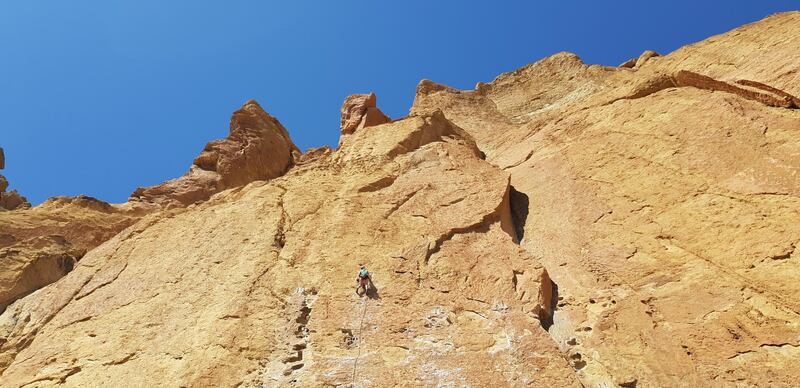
[130,100,300,207]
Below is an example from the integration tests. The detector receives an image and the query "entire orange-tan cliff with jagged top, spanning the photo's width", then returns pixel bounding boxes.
[0,12,800,387]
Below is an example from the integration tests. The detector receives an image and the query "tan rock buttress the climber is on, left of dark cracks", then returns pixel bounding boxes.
[0,112,578,386]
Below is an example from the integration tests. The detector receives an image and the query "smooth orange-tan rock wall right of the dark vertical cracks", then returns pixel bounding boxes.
[412,12,800,386]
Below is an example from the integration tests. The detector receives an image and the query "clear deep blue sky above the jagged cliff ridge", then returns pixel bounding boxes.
[0,0,798,203]
